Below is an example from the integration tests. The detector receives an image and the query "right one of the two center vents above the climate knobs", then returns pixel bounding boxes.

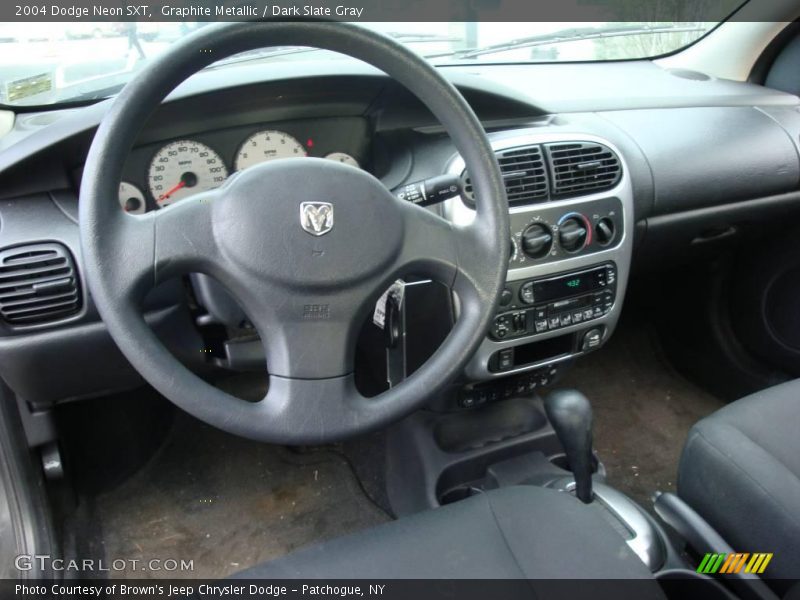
[545,142,622,197]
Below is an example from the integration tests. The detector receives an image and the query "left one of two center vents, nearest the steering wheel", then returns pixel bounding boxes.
[462,146,547,206]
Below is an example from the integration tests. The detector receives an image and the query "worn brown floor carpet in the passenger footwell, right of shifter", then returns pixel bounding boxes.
[559,319,723,510]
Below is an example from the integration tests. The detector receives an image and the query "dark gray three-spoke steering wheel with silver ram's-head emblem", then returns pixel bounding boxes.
[80,21,509,444]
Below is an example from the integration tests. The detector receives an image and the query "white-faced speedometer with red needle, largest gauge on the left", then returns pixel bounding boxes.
[147,140,228,206]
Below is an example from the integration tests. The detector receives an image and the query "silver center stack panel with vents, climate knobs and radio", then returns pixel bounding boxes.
[445,130,634,386]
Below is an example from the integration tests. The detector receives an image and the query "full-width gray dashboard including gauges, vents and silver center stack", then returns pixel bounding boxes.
[0,61,800,406]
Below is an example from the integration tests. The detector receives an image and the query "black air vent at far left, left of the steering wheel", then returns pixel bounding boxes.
[0,243,81,325]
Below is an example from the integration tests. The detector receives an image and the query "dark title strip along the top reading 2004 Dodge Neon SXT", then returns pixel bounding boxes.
[6,0,752,22]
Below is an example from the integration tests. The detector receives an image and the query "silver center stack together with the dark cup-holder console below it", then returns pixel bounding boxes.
[387,130,634,514]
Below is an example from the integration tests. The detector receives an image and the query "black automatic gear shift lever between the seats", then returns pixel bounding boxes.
[544,390,594,504]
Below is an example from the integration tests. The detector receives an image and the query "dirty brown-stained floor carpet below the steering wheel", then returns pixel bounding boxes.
[86,413,389,578]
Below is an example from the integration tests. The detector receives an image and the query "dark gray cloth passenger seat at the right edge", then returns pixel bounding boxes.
[678,380,800,593]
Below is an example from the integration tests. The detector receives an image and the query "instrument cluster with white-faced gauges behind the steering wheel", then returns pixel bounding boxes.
[119,119,368,214]
